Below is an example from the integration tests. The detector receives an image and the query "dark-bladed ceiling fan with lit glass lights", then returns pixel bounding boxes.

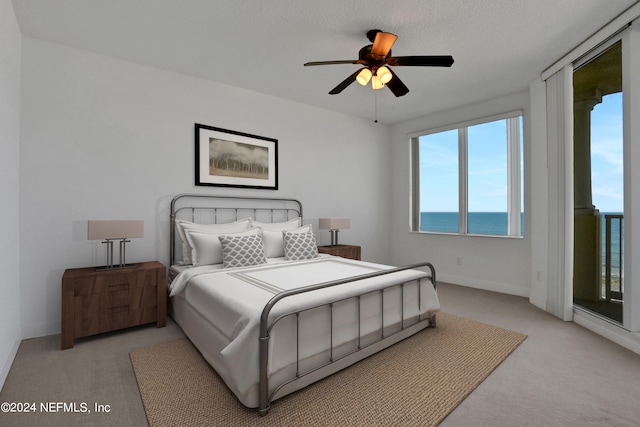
[304,30,453,96]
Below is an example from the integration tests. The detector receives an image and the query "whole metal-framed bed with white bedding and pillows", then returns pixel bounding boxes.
[168,194,440,415]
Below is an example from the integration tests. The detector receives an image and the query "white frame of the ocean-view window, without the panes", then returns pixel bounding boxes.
[407,110,524,238]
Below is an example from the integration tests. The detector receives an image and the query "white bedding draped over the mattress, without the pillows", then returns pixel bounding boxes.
[170,256,440,407]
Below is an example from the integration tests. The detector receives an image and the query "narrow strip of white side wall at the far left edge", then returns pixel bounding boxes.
[0,0,22,385]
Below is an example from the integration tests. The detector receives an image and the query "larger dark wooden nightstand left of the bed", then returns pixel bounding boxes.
[61,261,167,350]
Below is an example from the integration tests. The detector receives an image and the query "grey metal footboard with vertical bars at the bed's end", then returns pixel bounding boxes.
[258,262,436,415]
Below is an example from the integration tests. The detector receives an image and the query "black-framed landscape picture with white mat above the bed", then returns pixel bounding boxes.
[195,123,278,190]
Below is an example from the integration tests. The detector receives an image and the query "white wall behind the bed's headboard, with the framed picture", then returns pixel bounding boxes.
[20,38,389,338]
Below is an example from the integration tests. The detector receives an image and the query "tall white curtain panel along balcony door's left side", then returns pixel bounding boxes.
[545,65,573,321]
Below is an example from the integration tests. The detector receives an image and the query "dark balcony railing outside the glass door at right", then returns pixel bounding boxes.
[604,214,624,301]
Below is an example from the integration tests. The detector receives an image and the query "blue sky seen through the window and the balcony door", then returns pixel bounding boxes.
[420,93,623,213]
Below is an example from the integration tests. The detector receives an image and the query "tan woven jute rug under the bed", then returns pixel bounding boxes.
[130,313,526,427]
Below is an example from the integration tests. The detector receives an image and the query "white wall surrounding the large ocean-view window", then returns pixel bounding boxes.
[391,92,531,297]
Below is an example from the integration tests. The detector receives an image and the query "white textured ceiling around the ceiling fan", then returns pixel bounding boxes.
[13,0,636,123]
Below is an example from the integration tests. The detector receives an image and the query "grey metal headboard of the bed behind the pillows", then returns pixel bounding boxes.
[169,194,302,265]
